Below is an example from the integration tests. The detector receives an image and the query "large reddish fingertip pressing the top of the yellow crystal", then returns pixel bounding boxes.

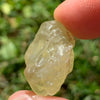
[54,0,100,39]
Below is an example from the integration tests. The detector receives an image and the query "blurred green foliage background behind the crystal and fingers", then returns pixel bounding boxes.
[0,0,100,100]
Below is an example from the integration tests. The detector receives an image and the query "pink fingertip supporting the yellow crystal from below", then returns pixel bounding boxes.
[8,90,67,100]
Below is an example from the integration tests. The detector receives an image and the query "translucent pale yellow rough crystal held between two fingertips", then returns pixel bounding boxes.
[24,21,75,96]
